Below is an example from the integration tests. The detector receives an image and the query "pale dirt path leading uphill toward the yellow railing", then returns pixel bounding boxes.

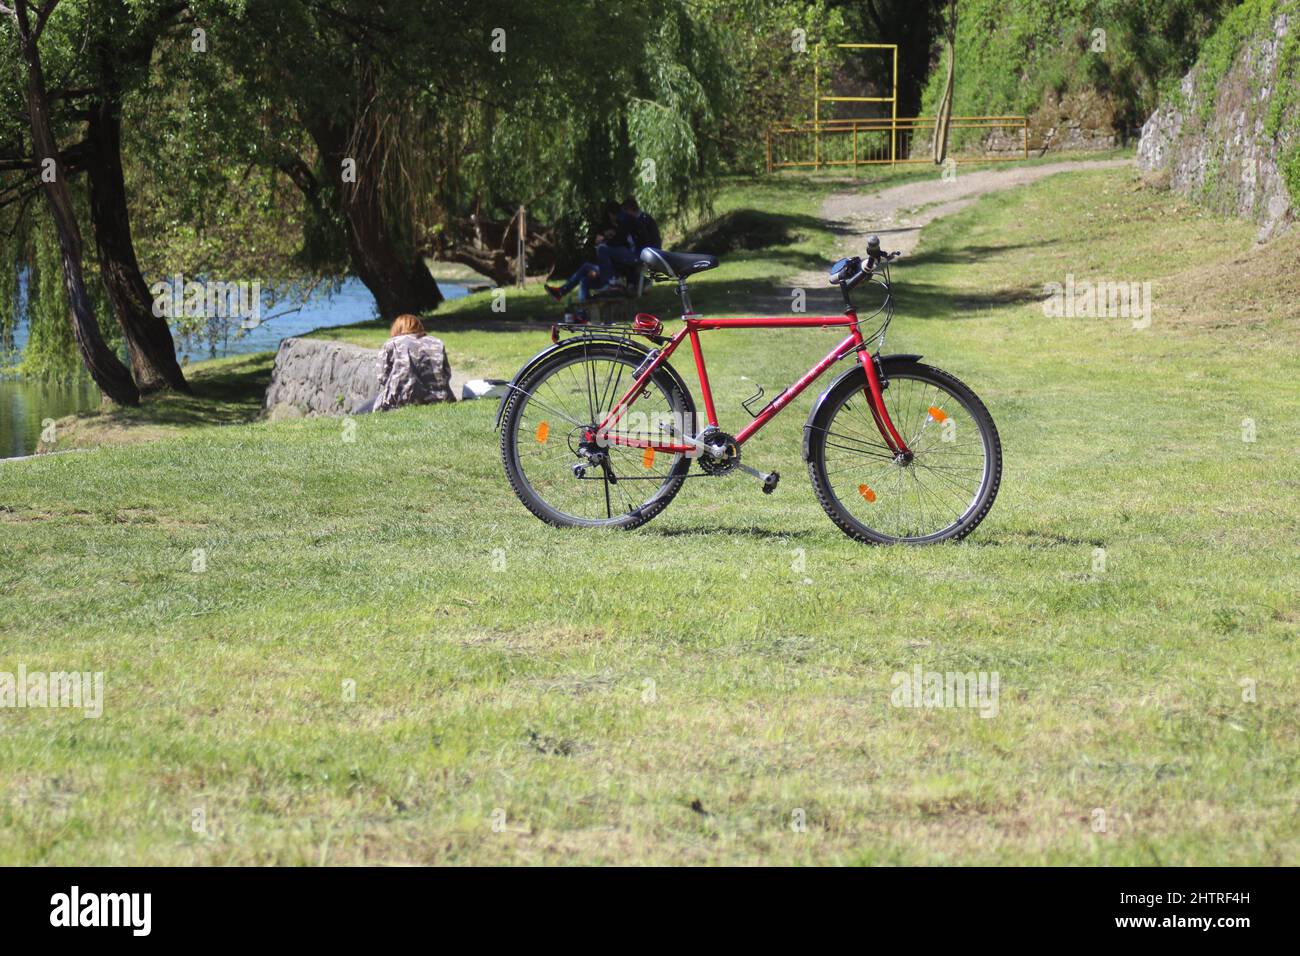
[792,159,1132,286]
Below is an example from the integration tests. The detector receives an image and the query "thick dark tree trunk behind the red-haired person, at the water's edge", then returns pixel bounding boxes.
[309,62,442,325]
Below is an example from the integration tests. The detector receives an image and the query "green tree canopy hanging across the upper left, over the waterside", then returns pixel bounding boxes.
[0,0,842,348]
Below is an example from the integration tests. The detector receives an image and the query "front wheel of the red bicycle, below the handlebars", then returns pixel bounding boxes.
[809,359,1002,544]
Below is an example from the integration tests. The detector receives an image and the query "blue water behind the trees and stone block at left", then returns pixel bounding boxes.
[0,278,468,458]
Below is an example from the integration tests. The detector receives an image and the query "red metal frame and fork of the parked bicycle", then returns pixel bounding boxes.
[590,310,909,455]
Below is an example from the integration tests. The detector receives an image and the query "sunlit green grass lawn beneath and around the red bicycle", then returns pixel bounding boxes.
[0,169,1300,864]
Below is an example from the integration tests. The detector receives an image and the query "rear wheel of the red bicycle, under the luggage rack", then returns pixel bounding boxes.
[501,342,696,528]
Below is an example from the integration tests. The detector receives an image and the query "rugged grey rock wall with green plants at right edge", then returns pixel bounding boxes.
[1138,12,1300,239]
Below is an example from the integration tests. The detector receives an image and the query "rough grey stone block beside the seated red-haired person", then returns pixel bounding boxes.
[265,338,454,418]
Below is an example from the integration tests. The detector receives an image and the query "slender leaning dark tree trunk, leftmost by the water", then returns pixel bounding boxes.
[14,0,140,405]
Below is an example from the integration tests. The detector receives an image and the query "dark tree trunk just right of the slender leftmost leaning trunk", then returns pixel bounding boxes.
[86,91,190,393]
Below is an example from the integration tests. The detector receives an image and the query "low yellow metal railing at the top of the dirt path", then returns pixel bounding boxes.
[767,115,1030,173]
